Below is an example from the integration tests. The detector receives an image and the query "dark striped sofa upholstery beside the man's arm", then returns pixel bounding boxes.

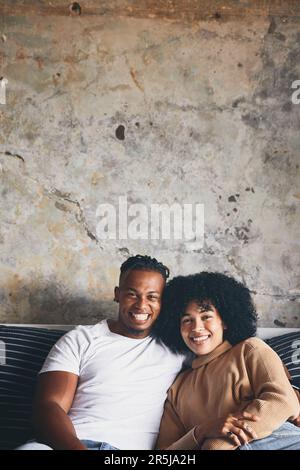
[0,326,66,449]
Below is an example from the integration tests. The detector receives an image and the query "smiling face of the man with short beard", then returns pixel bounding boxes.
[115,270,165,339]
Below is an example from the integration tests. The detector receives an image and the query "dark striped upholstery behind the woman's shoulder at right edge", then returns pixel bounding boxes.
[266,331,300,388]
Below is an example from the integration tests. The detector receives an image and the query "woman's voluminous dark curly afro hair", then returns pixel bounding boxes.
[152,272,257,352]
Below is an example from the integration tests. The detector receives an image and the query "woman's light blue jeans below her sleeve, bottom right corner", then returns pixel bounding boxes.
[239,422,300,450]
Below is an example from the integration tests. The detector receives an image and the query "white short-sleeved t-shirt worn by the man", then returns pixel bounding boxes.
[40,320,185,450]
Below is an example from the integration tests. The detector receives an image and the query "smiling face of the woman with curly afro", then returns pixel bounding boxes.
[180,301,226,356]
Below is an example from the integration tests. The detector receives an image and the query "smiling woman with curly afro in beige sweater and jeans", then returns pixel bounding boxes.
[156,272,300,450]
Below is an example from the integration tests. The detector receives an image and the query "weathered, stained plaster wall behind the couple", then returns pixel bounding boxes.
[0,2,300,327]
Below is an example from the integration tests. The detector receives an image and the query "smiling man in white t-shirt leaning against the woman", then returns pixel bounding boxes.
[19,255,185,450]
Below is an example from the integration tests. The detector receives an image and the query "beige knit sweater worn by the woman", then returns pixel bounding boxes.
[157,338,300,450]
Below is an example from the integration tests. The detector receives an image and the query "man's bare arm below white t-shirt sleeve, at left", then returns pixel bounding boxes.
[33,371,86,450]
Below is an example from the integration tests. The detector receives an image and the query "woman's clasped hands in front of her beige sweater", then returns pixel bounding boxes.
[195,411,260,447]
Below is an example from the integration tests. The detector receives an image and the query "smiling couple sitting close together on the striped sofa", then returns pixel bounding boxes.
[19,255,300,450]
